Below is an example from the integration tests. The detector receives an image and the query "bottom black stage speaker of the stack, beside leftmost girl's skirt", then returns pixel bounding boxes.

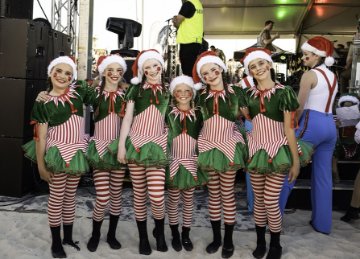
[0,137,38,197]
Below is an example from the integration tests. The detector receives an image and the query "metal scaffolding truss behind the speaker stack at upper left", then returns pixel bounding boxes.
[51,0,79,55]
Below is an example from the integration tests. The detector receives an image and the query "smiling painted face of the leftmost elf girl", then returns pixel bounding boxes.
[50,63,73,89]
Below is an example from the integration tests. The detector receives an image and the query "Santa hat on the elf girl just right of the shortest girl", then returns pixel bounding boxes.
[192,51,227,90]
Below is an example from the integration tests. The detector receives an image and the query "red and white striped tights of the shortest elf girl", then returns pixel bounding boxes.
[167,187,195,228]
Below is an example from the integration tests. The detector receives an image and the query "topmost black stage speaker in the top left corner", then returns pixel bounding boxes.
[0,0,34,19]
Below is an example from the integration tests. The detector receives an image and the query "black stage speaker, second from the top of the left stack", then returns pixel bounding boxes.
[0,19,71,79]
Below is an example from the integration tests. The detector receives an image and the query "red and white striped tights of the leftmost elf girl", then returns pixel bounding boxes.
[48,173,80,227]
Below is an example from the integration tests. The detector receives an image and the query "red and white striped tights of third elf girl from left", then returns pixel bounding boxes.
[128,164,165,221]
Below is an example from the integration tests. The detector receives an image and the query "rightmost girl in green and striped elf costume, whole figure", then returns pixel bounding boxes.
[240,48,311,259]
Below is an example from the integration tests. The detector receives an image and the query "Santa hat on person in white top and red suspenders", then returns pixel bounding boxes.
[301,36,335,67]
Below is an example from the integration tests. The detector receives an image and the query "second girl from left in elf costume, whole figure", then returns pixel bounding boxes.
[87,55,127,252]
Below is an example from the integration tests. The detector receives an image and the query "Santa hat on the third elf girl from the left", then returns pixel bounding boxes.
[130,49,164,85]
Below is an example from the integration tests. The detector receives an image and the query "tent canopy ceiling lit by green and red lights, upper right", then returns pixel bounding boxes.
[202,0,360,38]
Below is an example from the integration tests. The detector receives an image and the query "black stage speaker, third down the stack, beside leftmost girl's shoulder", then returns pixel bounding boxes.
[0,78,47,138]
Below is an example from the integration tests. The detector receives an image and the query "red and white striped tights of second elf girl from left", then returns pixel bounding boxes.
[93,170,125,222]
